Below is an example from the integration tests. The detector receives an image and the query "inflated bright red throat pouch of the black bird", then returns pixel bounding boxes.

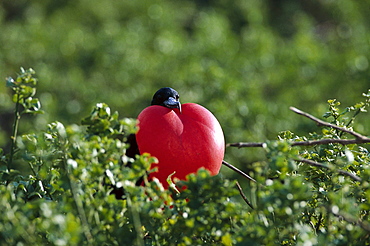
[136,103,225,189]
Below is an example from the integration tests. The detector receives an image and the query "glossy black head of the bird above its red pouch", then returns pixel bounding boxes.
[151,87,181,113]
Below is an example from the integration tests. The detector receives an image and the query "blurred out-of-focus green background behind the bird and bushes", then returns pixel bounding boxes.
[0,0,370,177]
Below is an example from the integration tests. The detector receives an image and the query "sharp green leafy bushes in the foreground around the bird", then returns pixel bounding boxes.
[0,69,370,245]
